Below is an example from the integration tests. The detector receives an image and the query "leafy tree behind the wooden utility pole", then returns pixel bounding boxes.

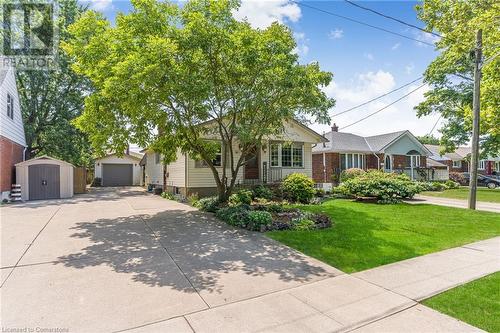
[416,0,500,156]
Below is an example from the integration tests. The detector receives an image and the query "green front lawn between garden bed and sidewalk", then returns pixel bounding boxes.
[267,200,500,273]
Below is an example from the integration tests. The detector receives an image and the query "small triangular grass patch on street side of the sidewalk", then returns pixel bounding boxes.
[423,272,500,332]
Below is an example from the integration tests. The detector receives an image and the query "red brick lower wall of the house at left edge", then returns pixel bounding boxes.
[0,136,24,192]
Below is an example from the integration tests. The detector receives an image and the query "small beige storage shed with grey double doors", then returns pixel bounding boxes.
[16,156,74,201]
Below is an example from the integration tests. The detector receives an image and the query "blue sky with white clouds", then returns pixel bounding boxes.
[84,0,440,137]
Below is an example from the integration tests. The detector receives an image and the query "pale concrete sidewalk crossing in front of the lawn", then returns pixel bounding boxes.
[122,237,500,333]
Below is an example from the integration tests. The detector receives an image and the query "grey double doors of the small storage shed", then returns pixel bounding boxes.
[28,164,61,200]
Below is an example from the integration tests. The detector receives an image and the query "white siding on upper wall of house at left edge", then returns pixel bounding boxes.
[0,68,26,147]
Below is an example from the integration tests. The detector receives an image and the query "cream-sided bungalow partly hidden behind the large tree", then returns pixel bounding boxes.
[158,120,326,196]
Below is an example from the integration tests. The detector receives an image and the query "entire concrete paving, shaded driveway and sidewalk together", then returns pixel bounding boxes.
[0,188,500,332]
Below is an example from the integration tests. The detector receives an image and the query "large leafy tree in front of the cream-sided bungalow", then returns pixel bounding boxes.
[65,0,334,200]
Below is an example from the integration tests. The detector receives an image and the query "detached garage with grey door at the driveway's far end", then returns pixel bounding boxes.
[94,151,143,186]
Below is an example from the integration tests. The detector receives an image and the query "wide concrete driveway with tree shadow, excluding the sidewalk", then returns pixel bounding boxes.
[0,188,341,332]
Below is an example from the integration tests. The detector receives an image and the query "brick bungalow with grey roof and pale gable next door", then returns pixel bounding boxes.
[313,124,442,186]
